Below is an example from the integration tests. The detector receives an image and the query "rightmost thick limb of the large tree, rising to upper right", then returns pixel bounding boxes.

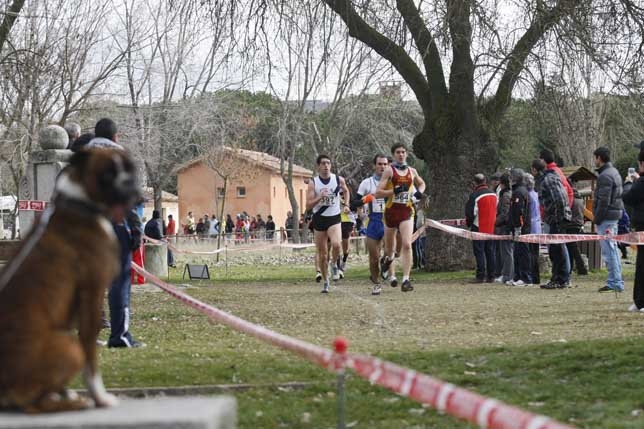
[484,0,583,122]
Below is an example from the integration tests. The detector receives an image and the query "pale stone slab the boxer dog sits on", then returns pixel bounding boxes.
[0,396,237,429]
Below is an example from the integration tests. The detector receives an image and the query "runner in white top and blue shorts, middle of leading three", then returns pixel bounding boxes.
[354,154,390,295]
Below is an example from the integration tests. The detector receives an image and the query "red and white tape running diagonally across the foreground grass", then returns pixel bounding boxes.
[132,263,574,429]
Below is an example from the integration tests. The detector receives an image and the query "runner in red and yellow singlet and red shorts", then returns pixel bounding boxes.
[375,143,425,292]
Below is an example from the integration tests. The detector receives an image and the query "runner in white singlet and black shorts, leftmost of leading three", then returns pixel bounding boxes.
[306,155,350,293]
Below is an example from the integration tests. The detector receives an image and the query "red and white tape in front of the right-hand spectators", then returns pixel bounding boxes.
[425,219,644,244]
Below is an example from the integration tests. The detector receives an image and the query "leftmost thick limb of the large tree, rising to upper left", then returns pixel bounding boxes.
[324,0,431,111]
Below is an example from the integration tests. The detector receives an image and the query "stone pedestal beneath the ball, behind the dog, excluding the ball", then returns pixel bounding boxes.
[18,149,72,237]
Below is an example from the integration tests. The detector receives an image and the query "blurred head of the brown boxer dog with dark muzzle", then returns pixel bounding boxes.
[61,149,141,209]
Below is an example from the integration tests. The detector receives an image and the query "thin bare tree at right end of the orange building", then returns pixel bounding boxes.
[260,1,382,240]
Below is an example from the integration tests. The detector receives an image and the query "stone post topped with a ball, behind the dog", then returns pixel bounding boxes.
[18,125,72,237]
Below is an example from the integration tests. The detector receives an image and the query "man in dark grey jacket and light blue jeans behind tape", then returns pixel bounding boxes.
[593,147,624,292]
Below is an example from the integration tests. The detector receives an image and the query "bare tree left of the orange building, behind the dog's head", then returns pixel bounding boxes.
[113,0,235,210]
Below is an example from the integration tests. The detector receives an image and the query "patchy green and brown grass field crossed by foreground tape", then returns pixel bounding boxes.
[93,251,644,428]
